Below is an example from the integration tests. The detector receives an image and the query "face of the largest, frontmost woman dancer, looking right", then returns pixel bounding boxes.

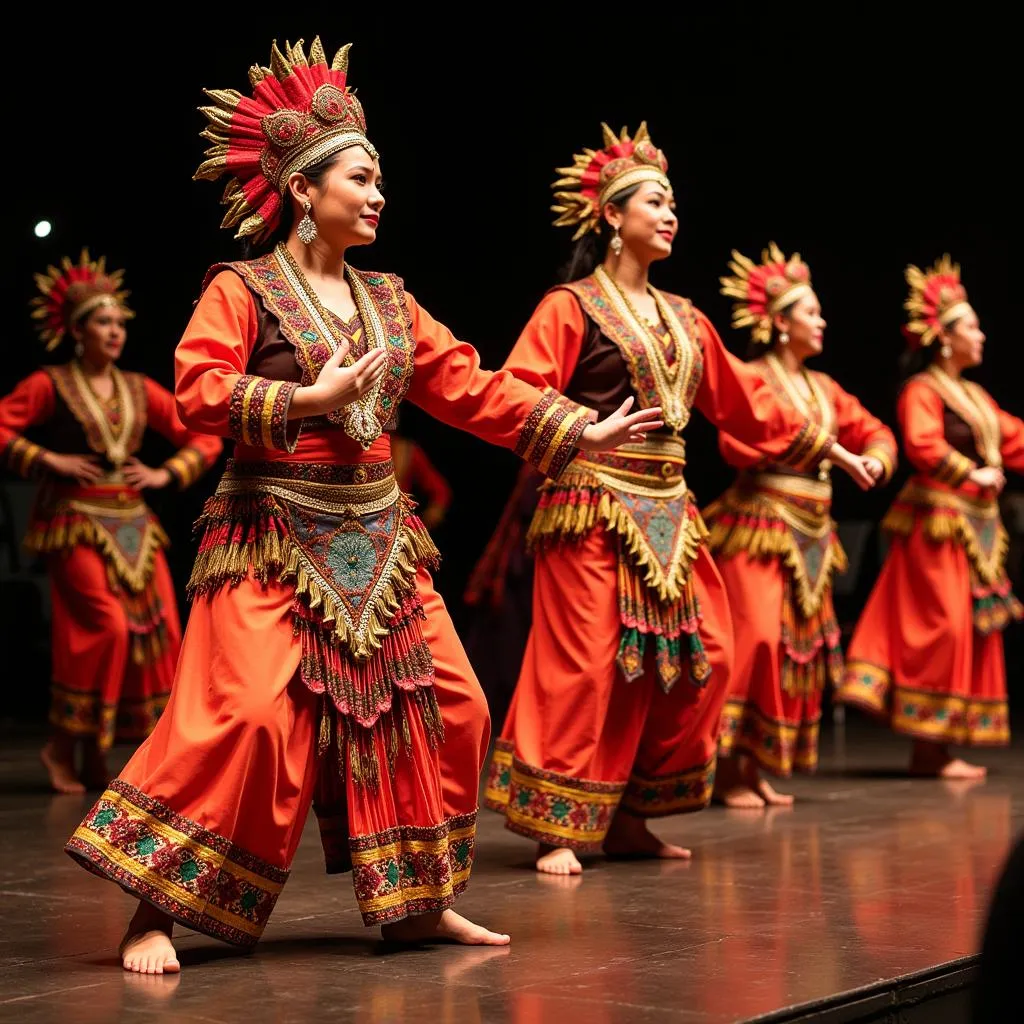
[290,145,384,251]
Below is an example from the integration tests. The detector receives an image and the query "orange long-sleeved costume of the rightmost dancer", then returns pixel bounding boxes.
[839,366,1024,744]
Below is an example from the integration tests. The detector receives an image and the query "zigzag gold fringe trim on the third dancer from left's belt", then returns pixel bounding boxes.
[526,468,708,602]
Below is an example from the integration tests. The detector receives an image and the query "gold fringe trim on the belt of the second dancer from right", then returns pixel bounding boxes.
[703,487,849,618]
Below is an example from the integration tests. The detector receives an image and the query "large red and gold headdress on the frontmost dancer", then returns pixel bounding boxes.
[194,38,377,239]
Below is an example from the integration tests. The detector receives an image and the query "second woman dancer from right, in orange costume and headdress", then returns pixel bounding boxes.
[705,243,896,808]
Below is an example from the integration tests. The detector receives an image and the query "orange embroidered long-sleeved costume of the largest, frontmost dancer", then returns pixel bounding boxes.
[69,251,591,945]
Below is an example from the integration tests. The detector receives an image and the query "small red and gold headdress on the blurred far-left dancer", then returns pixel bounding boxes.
[32,249,135,352]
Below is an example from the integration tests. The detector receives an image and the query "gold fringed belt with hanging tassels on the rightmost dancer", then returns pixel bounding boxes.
[882,477,1024,634]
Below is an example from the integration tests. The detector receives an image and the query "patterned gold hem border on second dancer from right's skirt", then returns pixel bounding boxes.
[718,700,821,778]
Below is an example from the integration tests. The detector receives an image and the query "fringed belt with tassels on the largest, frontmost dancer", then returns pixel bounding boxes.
[188,461,441,784]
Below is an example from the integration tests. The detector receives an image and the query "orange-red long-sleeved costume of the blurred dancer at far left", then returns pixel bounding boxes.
[0,364,221,749]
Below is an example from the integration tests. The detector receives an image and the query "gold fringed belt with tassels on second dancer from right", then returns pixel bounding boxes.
[703,472,847,694]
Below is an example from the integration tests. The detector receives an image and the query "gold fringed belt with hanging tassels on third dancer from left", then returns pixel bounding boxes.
[526,437,711,691]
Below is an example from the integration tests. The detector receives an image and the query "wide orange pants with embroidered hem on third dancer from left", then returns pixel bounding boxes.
[486,527,732,850]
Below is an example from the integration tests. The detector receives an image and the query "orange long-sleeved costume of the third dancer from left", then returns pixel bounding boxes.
[486,280,830,850]
